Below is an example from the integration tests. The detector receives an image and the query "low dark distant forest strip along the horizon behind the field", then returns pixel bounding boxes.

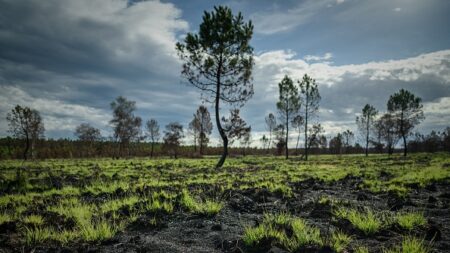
[0,127,450,159]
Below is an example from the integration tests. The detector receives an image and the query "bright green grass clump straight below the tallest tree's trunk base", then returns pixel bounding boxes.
[181,189,223,215]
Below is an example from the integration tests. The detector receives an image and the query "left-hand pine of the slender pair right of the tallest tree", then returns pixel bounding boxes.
[277,75,300,159]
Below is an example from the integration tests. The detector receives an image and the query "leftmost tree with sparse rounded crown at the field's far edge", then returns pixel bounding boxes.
[6,105,45,160]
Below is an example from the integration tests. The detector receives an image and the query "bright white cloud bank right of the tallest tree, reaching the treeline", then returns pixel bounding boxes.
[250,50,450,143]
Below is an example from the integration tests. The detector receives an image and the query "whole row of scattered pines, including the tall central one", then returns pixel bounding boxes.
[1,6,444,164]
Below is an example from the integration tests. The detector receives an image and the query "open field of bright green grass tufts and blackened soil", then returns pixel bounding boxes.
[0,153,450,252]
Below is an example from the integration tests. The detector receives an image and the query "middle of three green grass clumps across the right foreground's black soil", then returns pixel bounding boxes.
[335,207,383,235]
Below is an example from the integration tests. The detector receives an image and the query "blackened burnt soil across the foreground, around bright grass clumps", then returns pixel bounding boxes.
[0,176,450,252]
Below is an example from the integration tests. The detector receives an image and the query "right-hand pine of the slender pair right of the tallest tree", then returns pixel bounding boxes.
[298,74,321,160]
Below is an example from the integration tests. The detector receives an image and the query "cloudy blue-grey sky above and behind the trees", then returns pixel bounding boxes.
[0,0,450,145]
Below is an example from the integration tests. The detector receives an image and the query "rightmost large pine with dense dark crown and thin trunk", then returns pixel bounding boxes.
[387,89,425,156]
